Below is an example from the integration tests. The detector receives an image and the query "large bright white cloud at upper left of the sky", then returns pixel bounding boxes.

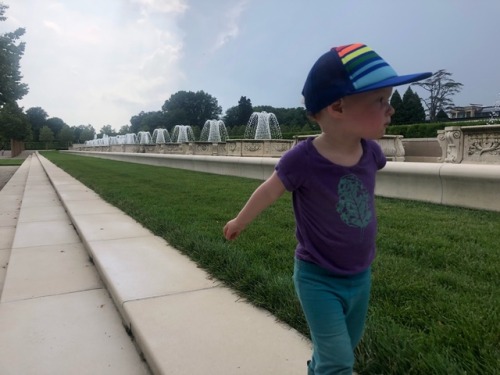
[11,0,188,129]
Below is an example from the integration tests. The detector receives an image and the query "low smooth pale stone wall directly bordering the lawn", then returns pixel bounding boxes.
[62,151,500,211]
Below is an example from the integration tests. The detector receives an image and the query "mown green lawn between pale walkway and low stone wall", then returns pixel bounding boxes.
[43,152,500,375]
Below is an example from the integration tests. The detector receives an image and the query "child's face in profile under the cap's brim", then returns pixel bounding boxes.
[341,87,394,139]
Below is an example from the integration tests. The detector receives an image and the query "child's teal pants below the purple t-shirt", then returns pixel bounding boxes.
[293,259,371,375]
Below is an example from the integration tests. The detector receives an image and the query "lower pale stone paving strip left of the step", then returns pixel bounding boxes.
[0,156,151,375]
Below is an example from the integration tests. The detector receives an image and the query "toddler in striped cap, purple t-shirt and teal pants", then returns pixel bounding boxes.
[224,43,432,375]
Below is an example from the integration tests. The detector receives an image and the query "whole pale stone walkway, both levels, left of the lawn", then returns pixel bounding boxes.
[0,155,310,375]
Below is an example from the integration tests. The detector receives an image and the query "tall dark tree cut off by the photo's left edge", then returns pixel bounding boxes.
[0,3,28,106]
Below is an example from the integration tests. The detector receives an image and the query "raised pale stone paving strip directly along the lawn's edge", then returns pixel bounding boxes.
[37,151,311,375]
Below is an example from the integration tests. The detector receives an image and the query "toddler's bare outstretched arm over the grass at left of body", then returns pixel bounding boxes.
[224,172,285,240]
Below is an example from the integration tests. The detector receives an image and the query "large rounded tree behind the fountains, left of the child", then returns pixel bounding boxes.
[161,91,222,128]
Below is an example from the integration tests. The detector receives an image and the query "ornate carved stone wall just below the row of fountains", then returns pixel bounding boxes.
[72,125,500,164]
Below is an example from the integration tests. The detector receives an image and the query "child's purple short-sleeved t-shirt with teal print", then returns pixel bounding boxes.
[276,138,386,275]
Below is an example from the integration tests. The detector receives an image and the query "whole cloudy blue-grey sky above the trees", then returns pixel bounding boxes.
[0,0,500,131]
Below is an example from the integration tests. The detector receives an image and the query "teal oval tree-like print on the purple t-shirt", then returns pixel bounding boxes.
[337,174,373,240]
